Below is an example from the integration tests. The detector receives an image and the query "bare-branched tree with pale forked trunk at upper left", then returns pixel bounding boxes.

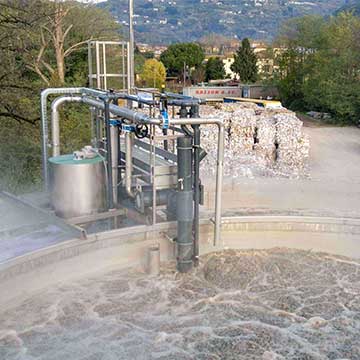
[28,0,119,86]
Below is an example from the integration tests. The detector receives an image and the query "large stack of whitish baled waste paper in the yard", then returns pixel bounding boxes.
[200,103,310,178]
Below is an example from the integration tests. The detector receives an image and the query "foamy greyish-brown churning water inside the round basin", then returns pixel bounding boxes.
[0,249,360,360]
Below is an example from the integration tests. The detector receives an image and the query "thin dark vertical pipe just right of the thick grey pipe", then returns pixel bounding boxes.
[190,105,200,266]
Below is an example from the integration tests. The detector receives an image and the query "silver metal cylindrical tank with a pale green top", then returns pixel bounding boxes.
[49,155,105,218]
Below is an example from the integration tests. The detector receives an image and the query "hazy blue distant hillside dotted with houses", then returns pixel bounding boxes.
[99,0,348,44]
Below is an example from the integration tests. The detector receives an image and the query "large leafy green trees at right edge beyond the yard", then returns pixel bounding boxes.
[274,12,360,123]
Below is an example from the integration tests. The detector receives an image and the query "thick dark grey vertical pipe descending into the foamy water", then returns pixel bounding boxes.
[176,136,193,273]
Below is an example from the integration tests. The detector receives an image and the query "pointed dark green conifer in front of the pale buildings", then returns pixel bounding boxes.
[231,38,258,83]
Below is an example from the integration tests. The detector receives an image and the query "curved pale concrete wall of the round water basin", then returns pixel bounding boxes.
[0,216,360,306]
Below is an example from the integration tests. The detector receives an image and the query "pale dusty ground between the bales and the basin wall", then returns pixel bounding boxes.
[205,125,360,217]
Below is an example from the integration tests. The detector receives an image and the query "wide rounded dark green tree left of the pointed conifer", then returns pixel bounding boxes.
[160,43,205,77]
